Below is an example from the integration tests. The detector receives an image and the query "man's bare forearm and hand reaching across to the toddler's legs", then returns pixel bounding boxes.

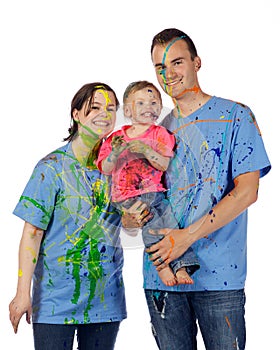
[146,171,259,270]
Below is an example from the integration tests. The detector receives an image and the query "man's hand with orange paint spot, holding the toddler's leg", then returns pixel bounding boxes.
[146,228,194,271]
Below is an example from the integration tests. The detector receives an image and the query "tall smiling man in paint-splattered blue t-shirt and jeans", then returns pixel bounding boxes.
[144,28,271,350]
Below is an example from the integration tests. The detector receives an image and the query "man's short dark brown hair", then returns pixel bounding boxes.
[151,28,197,60]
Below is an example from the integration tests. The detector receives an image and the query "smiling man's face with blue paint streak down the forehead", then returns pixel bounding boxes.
[152,39,200,100]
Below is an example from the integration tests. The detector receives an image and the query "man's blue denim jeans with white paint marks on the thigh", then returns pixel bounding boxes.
[145,289,246,350]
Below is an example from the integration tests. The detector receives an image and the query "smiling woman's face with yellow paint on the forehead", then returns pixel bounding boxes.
[73,89,117,139]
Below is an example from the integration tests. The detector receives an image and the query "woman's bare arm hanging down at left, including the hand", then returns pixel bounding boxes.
[9,222,44,333]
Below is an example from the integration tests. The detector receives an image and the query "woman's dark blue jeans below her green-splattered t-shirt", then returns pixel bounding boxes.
[33,322,120,350]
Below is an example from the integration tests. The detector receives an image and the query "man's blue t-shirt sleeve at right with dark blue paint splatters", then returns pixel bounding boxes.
[231,106,271,178]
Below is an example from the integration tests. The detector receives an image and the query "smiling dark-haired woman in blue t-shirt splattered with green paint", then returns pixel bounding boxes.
[9,83,126,350]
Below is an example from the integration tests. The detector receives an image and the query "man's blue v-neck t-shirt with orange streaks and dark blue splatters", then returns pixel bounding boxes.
[143,97,271,291]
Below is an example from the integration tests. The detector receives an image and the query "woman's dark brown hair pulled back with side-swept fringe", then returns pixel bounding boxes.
[63,83,120,141]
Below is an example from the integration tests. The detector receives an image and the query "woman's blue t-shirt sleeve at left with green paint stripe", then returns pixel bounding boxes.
[13,161,58,230]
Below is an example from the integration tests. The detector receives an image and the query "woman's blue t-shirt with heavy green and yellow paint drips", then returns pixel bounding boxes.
[14,143,126,324]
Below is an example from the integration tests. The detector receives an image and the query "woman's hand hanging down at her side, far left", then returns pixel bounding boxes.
[9,295,32,333]
